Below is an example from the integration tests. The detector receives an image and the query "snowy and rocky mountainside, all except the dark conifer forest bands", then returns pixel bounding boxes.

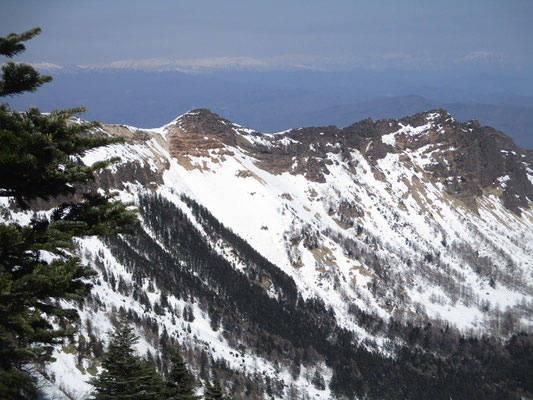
[2,110,533,399]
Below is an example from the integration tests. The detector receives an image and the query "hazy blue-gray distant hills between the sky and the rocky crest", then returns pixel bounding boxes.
[11,69,533,149]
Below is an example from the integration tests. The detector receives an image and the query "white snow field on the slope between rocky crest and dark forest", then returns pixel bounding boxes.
[86,112,533,331]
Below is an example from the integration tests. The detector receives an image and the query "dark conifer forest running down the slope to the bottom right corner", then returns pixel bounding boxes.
[101,195,533,399]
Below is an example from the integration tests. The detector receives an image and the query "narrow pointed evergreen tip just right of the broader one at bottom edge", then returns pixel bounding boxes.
[164,347,197,400]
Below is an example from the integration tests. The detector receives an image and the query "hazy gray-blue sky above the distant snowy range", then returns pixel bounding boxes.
[0,0,533,70]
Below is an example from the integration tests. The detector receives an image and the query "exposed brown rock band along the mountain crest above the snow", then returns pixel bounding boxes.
[118,109,533,214]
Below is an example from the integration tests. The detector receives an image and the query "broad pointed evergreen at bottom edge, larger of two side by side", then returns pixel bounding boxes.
[91,322,162,400]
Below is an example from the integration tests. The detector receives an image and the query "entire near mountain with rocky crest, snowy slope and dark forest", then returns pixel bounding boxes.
[2,109,533,399]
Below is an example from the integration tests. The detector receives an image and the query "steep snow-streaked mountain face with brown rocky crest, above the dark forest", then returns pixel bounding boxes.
[116,110,533,328]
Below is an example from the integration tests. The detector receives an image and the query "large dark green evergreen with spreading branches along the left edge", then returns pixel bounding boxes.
[0,28,136,399]
